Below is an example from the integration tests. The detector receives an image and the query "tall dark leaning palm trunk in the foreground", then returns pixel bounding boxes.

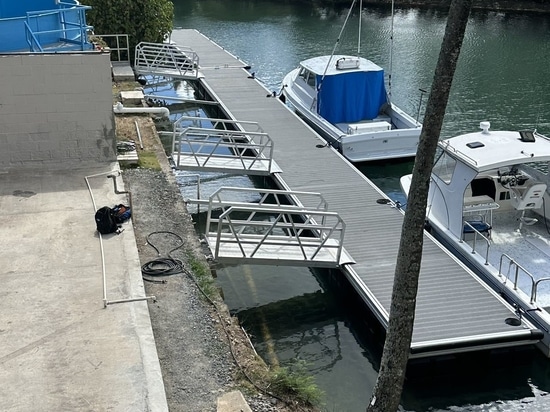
[367,0,473,412]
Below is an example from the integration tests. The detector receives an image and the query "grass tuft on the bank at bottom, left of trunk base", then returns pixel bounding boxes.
[271,361,324,406]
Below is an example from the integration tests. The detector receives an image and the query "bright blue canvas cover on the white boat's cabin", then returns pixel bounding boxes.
[317,70,387,124]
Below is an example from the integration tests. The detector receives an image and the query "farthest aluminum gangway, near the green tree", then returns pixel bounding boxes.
[134,42,199,80]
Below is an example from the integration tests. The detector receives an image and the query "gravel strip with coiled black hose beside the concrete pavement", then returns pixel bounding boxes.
[123,169,236,412]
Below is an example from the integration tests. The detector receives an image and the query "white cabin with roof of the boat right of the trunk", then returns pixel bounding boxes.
[428,122,550,238]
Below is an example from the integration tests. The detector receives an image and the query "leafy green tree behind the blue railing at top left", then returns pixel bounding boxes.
[86,0,174,60]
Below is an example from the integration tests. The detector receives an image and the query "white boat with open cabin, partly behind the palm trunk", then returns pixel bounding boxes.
[401,122,550,356]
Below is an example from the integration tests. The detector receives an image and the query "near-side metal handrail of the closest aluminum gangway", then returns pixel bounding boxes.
[207,205,345,263]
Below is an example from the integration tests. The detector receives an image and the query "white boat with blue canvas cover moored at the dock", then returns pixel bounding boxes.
[282,55,422,162]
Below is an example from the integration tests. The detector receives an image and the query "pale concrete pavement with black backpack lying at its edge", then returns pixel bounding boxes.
[0,164,168,411]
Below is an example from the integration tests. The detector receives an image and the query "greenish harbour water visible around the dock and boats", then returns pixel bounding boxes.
[172,0,550,412]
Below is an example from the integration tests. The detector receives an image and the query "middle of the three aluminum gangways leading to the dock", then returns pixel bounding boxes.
[165,116,281,176]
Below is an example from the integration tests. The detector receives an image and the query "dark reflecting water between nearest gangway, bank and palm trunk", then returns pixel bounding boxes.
[217,265,382,411]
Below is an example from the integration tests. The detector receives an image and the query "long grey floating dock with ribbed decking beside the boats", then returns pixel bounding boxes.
[172,30,540,358]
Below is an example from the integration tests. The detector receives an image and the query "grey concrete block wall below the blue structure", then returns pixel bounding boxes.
[0,52,116,169]
